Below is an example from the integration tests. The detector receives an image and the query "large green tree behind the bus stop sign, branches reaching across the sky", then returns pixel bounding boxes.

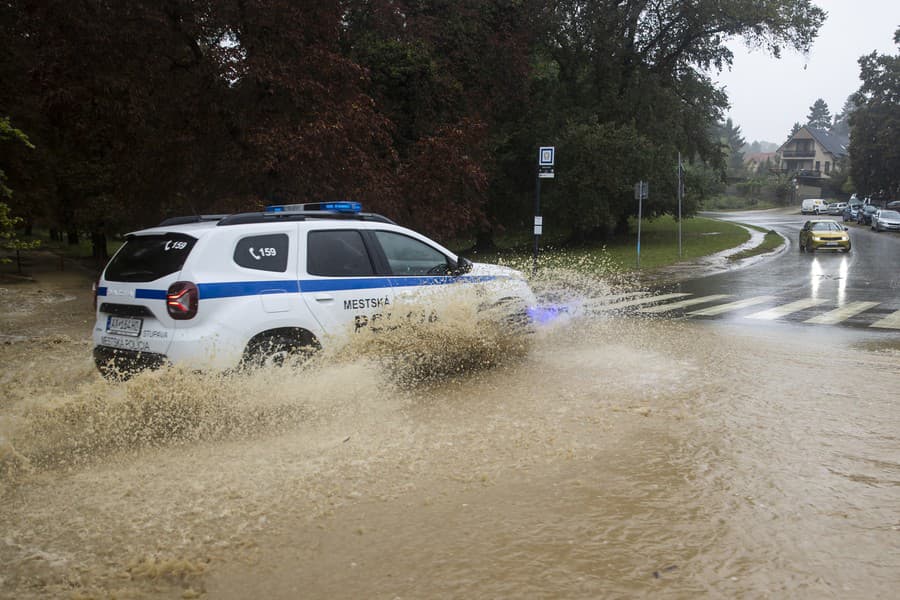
[530,0,825,239]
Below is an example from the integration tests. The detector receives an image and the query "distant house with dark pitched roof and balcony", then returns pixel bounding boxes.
[773,125,850,180]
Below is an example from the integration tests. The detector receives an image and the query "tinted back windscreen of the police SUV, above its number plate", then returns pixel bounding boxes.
[106,233,197,281]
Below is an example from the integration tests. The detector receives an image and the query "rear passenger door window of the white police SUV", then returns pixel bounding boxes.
[306,229,375,277]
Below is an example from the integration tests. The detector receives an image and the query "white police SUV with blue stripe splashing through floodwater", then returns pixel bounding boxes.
[93,202,534,376]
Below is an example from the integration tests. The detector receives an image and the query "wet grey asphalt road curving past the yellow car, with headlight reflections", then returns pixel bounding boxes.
[665,209,900,334]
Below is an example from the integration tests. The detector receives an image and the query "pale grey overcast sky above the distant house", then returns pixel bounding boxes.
[714,0,900,144]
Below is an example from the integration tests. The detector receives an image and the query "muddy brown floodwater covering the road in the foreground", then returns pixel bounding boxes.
[0,254,900,599]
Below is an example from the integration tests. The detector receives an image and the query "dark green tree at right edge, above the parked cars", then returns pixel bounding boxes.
[850,28,900,198]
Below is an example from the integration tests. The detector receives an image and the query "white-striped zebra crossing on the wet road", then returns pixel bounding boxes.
[583,293,900,330]
